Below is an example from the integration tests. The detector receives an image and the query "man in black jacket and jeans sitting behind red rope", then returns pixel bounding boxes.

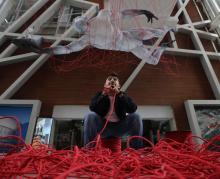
[84,73,143,149]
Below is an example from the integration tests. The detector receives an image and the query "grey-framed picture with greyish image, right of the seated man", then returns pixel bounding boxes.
[185,100,220,139]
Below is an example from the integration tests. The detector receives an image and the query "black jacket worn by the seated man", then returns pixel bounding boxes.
[90,92,137,120]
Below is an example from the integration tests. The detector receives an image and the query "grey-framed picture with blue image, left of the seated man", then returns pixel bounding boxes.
[0,100,41,144]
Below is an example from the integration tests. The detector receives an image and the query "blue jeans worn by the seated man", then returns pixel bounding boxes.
[83,112,143,149]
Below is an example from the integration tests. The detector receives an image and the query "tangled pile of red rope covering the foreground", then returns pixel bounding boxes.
[0,114,220,179]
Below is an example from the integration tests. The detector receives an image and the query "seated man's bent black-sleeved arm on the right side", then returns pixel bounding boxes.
[118,91,137,113]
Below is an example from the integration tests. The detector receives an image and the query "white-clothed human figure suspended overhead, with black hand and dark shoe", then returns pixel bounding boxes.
[13,9,175,65]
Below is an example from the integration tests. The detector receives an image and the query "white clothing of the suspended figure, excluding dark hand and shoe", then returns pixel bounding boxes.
[50,9,177,65]
